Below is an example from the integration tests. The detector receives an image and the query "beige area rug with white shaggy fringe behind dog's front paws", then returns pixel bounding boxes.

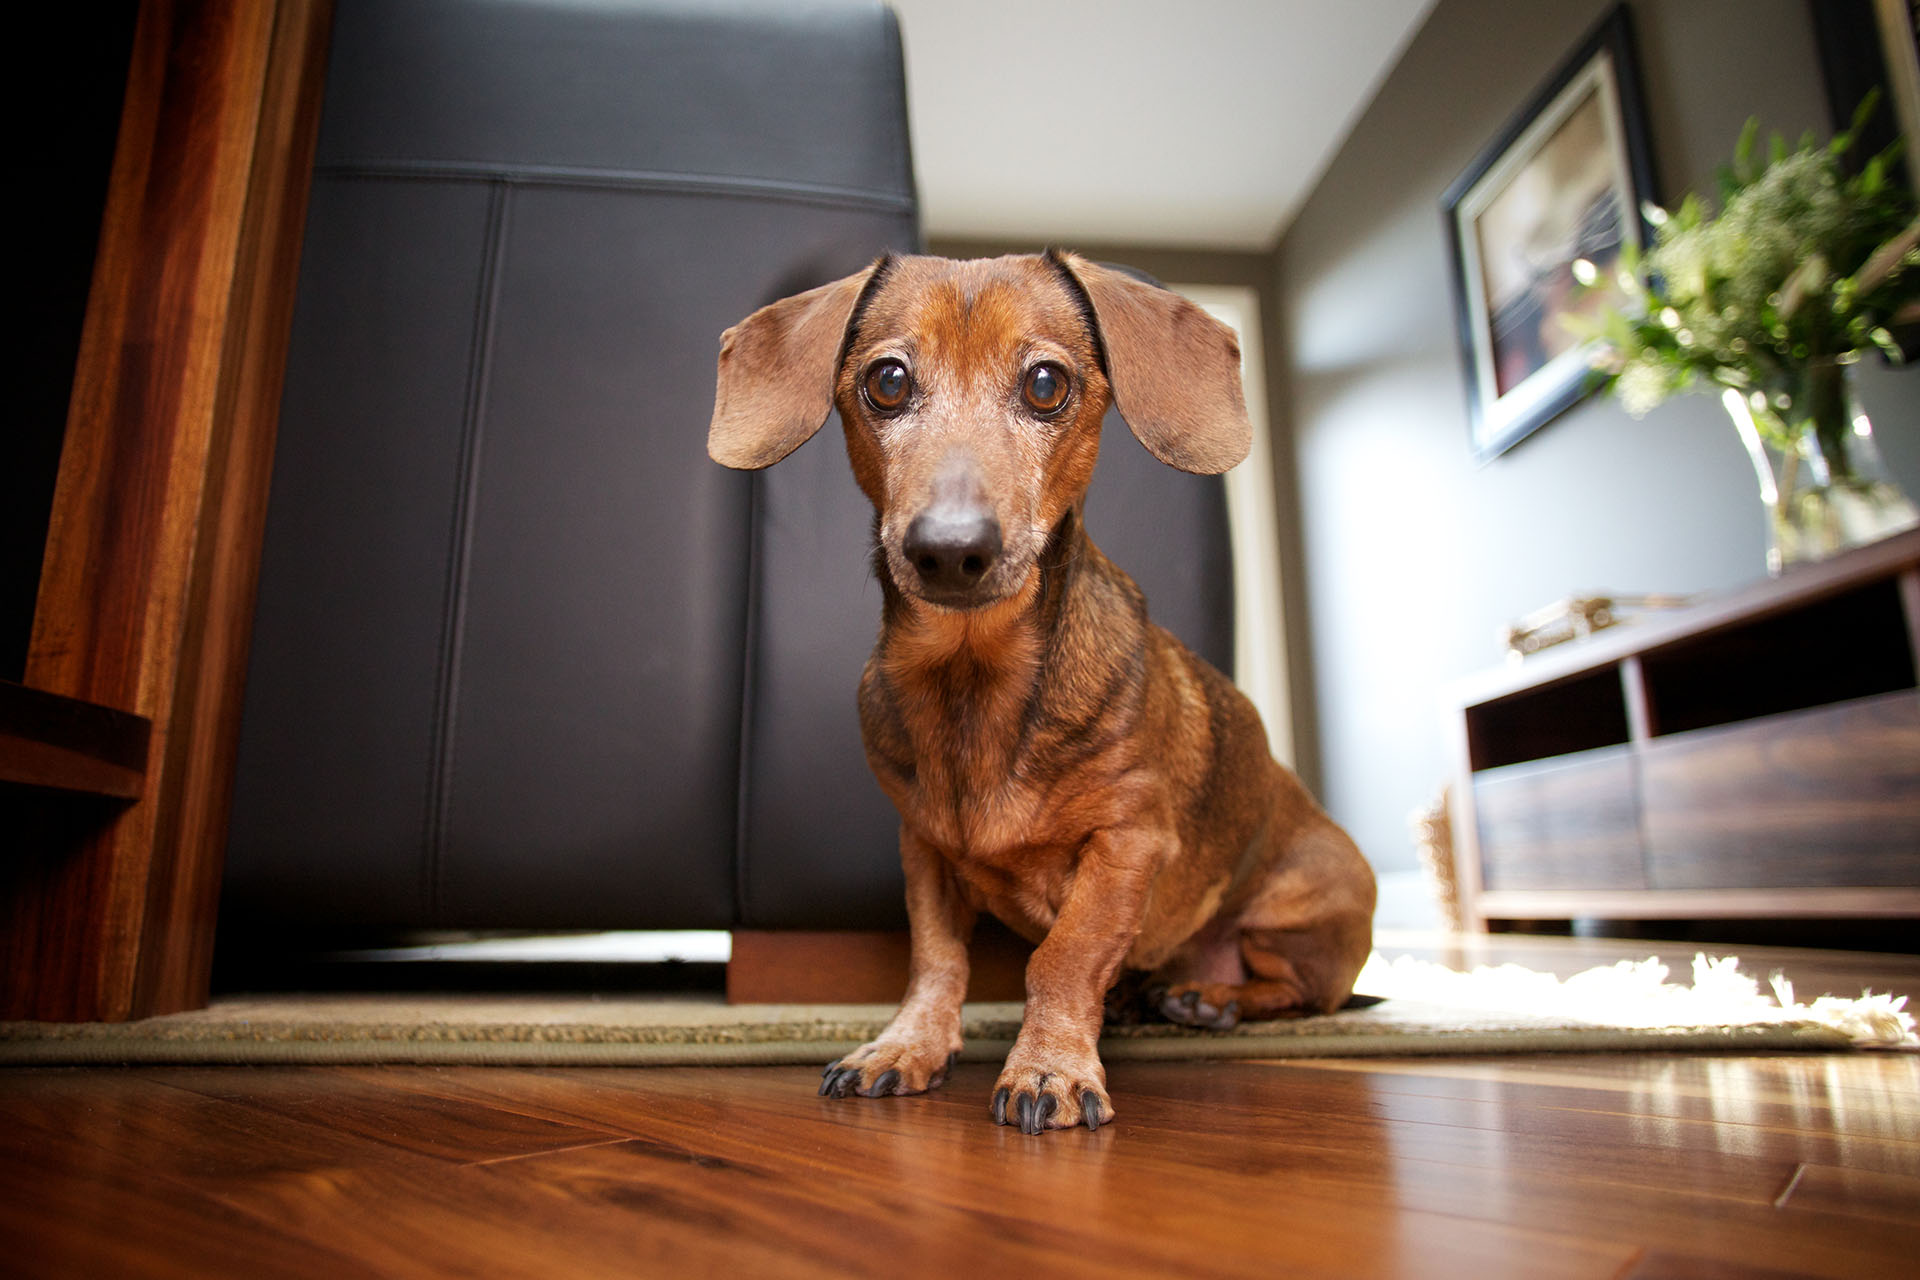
[0,956,1920,1065]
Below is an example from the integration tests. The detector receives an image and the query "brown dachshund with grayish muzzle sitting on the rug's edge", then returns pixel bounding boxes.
[707,253,1375,1134]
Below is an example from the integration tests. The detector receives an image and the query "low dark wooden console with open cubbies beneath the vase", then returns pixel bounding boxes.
[1453,530,1920,929]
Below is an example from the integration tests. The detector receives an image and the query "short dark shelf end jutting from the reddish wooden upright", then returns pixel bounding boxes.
[0,681,154,800]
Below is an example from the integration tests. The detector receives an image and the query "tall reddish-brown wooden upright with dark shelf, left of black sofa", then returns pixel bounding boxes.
[0,0,332,1021]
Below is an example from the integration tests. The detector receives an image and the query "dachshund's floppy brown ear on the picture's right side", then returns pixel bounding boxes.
[1054,253,1254,476]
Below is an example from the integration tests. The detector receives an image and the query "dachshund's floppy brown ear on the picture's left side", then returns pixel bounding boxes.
[707,267,876,470]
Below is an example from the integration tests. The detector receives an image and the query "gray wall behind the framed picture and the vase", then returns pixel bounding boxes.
[1271,0,1920,909]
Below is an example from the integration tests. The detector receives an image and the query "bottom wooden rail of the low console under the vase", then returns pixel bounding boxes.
[1473,885,1920,921]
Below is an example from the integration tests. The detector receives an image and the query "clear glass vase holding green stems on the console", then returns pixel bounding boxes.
[1720,361,1920,576]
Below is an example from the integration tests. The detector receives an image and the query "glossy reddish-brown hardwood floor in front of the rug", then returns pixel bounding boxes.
[0,942,1920,1280]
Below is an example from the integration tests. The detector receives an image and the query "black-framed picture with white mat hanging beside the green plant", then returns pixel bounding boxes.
[1444,6,1655,462]
